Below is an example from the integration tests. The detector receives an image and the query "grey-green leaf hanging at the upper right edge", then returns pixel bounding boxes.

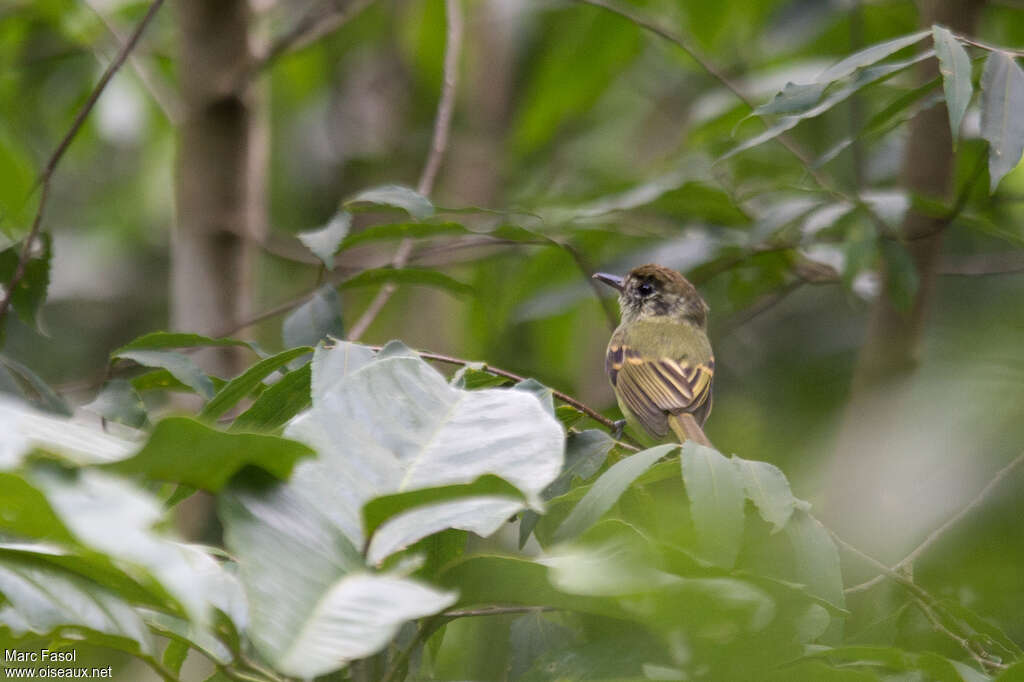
[981,50,1024,191]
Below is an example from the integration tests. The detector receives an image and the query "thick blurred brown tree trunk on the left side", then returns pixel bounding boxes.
[171,0,256,376]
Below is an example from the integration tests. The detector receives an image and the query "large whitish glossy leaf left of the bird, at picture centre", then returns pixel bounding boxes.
[286,348,564,545]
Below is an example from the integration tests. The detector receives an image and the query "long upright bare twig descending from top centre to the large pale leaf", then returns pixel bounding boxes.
[348,0,463,341]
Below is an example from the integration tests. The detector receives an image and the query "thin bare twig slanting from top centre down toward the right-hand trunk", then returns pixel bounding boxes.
[575,0,893,235]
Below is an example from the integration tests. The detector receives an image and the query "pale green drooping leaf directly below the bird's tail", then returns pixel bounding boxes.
[681,440,744,568]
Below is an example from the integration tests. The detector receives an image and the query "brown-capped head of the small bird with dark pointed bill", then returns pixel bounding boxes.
[594,263,709,329]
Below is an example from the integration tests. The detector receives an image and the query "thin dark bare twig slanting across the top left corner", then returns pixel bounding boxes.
[0,0,164,323]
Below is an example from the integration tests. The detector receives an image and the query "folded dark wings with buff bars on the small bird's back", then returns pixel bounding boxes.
[605,344,715,438]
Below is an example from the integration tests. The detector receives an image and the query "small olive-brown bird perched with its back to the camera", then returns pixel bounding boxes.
[594,264,715,445]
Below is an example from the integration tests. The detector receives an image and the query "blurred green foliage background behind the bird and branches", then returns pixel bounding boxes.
[0,0,1024,675]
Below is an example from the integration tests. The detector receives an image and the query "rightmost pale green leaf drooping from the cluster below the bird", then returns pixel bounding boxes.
[785,509,846,627]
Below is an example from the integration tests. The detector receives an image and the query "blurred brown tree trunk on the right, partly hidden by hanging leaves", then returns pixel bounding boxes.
[824,0,985,540]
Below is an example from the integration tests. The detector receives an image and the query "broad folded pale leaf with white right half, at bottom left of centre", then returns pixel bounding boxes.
[220,483,456,678]
